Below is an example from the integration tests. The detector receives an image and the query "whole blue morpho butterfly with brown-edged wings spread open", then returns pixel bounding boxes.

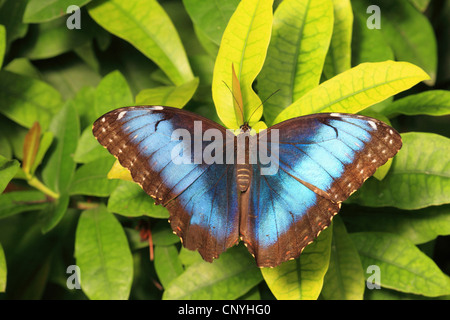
[93,106,402,267]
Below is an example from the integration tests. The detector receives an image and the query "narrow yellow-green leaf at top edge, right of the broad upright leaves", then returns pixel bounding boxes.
[323,0,353,79]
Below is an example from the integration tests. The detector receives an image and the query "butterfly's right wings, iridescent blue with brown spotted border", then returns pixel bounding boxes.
[240,113,402,267]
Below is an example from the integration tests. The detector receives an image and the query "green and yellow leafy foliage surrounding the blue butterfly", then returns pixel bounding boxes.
[0,0,450,299]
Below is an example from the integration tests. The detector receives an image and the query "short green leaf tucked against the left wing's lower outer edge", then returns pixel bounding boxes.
[108,181,169,218]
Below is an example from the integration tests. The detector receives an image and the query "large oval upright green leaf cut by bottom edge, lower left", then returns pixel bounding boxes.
[75,206,133,300]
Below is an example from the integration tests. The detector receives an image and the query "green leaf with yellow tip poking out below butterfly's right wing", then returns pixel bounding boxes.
[261,228,332,300]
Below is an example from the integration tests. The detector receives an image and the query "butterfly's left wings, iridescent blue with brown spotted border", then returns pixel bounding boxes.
[93,106,239,261]
